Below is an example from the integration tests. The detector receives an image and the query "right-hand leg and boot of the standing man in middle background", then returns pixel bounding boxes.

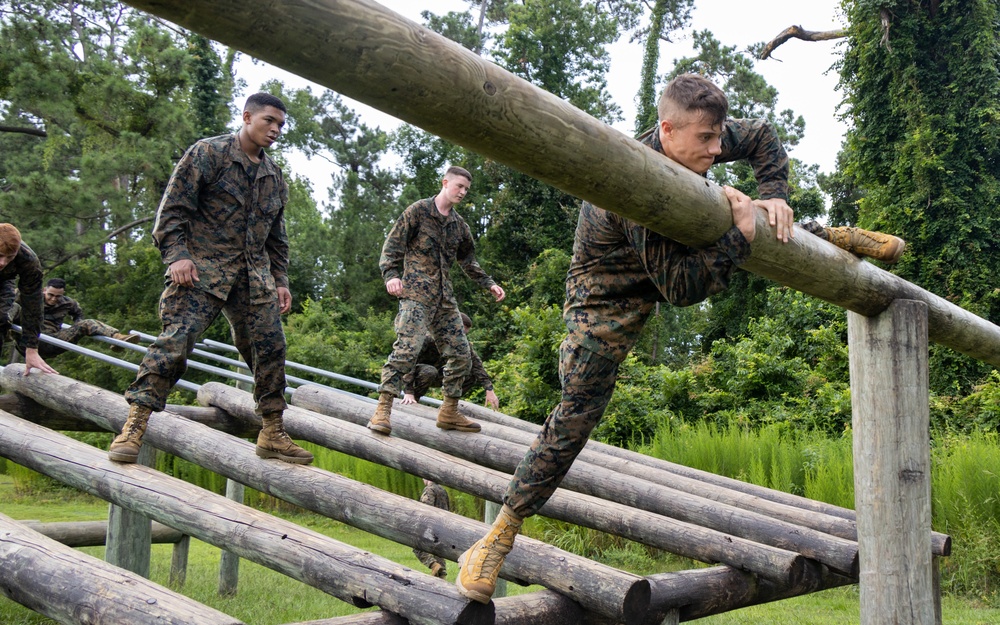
[430,308,482,432]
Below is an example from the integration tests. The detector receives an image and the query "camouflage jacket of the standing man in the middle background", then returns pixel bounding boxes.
[378,197,496,308]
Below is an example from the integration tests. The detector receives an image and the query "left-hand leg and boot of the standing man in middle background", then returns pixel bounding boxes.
[368,299,430,434]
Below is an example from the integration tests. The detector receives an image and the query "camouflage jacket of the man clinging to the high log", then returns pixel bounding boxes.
[564,119,788,362]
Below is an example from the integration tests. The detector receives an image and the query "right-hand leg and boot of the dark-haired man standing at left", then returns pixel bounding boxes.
[223,280,313,464]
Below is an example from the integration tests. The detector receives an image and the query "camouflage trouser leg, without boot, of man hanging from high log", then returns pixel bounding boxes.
[504,338,620,519]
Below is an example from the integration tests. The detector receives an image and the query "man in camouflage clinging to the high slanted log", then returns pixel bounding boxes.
[456,75,792,603]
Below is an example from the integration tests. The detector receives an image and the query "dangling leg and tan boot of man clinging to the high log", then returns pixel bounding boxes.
[455,338,618,603]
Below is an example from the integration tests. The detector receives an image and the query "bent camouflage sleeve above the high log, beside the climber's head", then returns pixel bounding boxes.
[715,119,788,201]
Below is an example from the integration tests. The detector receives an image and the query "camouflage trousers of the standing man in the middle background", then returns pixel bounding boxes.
[379,299,472,397]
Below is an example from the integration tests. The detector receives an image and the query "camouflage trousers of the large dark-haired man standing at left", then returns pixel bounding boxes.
[125,275,287,415]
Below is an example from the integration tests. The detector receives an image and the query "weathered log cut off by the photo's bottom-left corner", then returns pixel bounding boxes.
[0,512,241,625]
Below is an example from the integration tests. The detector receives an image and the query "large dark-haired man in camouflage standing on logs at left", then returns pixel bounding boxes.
[109,93,312,464]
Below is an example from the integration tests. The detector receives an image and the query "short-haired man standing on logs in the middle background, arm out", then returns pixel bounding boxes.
[368,167,505,434]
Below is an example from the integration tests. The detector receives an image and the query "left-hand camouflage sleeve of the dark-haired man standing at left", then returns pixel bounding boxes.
[153,141,211,265]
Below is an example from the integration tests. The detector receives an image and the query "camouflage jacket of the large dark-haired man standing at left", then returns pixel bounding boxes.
[153,134,288,304]
